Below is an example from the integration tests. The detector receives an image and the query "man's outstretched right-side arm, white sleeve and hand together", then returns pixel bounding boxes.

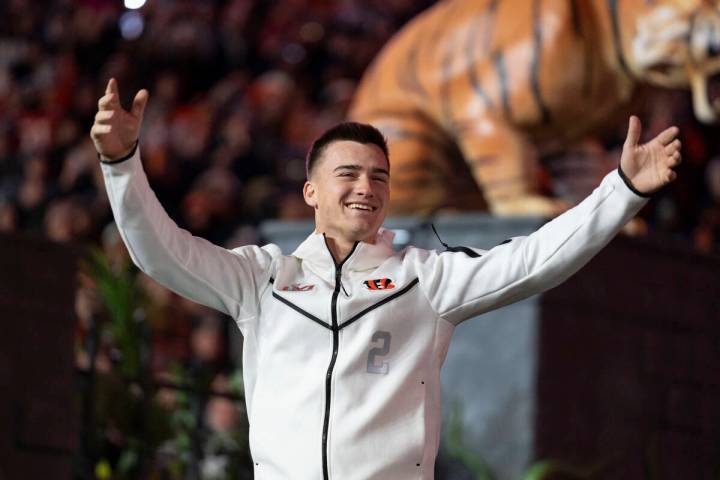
[417,116,681,324]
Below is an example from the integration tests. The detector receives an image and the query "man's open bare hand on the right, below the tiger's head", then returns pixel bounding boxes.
[620,115,681,194]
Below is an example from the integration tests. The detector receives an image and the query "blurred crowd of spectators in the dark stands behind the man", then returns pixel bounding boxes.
[0,0,720,478]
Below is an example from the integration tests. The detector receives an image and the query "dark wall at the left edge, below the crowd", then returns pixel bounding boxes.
[0,236,78,480]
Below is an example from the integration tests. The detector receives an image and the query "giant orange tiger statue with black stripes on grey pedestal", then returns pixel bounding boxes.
[350,0,720,216]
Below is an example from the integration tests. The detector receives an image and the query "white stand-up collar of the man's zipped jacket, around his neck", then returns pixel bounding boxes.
[292,228,395,275]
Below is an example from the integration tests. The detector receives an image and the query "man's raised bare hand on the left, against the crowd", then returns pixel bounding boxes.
[90,78,149,160]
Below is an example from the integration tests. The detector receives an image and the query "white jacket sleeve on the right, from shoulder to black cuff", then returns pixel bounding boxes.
[416,170,647,325]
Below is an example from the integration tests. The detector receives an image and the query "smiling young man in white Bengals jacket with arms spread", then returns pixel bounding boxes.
[91,79,680,480]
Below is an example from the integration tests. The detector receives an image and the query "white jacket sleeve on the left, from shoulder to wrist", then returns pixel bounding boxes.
[101,149,280,330]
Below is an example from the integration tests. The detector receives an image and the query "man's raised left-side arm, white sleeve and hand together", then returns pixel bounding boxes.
[90,79,279,329]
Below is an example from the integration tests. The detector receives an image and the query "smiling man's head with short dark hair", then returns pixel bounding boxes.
[303,140,390,242]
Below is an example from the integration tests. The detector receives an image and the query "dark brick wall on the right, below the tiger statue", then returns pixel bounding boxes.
[536,237,720,480]
